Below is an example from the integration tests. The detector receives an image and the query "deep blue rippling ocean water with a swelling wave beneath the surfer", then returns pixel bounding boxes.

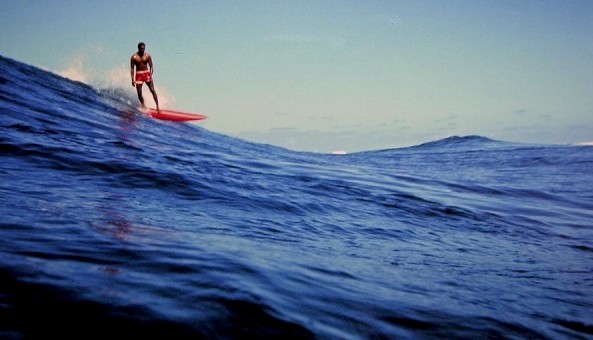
[0,53,593,339]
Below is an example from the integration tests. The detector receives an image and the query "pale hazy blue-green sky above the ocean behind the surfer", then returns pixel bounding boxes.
[0,0,593,152]
